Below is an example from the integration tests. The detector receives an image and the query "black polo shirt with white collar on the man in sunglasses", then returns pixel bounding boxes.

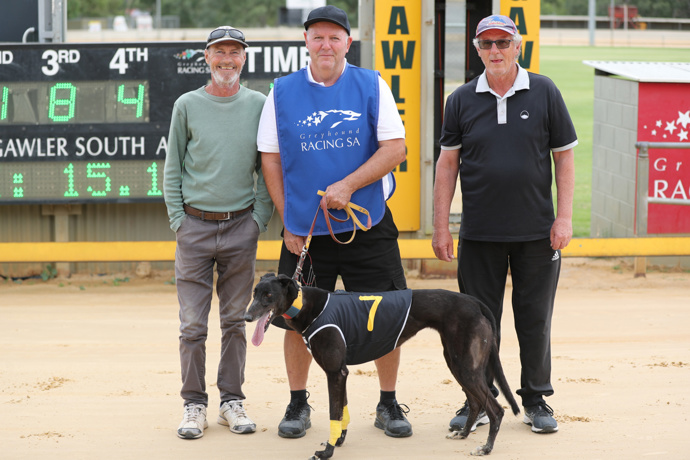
[441,66,577,242]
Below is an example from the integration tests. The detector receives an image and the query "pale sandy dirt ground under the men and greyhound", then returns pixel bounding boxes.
[0,259,690,460]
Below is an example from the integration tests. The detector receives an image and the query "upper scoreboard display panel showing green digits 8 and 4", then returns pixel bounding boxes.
[0,80,149,125]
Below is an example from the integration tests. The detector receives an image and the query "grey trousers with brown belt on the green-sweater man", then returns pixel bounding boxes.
[175,212,259,406]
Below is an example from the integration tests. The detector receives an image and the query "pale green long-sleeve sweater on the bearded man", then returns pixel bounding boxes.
[164,86,273,231]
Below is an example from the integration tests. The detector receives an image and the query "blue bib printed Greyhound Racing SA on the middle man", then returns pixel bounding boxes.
[273,64,387,236]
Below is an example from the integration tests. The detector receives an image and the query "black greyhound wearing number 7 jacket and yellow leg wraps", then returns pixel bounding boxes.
[245,273,520,459]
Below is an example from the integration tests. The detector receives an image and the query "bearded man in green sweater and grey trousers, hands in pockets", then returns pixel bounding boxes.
[164,26,273,439]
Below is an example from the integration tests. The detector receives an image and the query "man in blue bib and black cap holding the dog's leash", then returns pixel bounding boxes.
[257,6,412,438]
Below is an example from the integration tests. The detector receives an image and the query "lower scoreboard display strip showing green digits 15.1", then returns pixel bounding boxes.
[0,160,164,203]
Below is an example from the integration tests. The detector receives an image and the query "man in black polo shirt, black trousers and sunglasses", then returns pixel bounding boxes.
[432,15,577,433]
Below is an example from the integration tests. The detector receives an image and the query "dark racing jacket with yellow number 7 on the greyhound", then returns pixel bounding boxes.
[302,289,412,364]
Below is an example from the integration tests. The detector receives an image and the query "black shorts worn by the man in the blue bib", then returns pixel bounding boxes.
[273,207,407,329]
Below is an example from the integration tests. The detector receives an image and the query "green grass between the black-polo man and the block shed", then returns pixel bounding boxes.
[539,46,689,237]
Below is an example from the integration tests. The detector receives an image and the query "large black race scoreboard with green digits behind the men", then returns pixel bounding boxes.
[0,41,359,204]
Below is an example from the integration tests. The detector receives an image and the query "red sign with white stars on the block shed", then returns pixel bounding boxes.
[637,83,690,234]
